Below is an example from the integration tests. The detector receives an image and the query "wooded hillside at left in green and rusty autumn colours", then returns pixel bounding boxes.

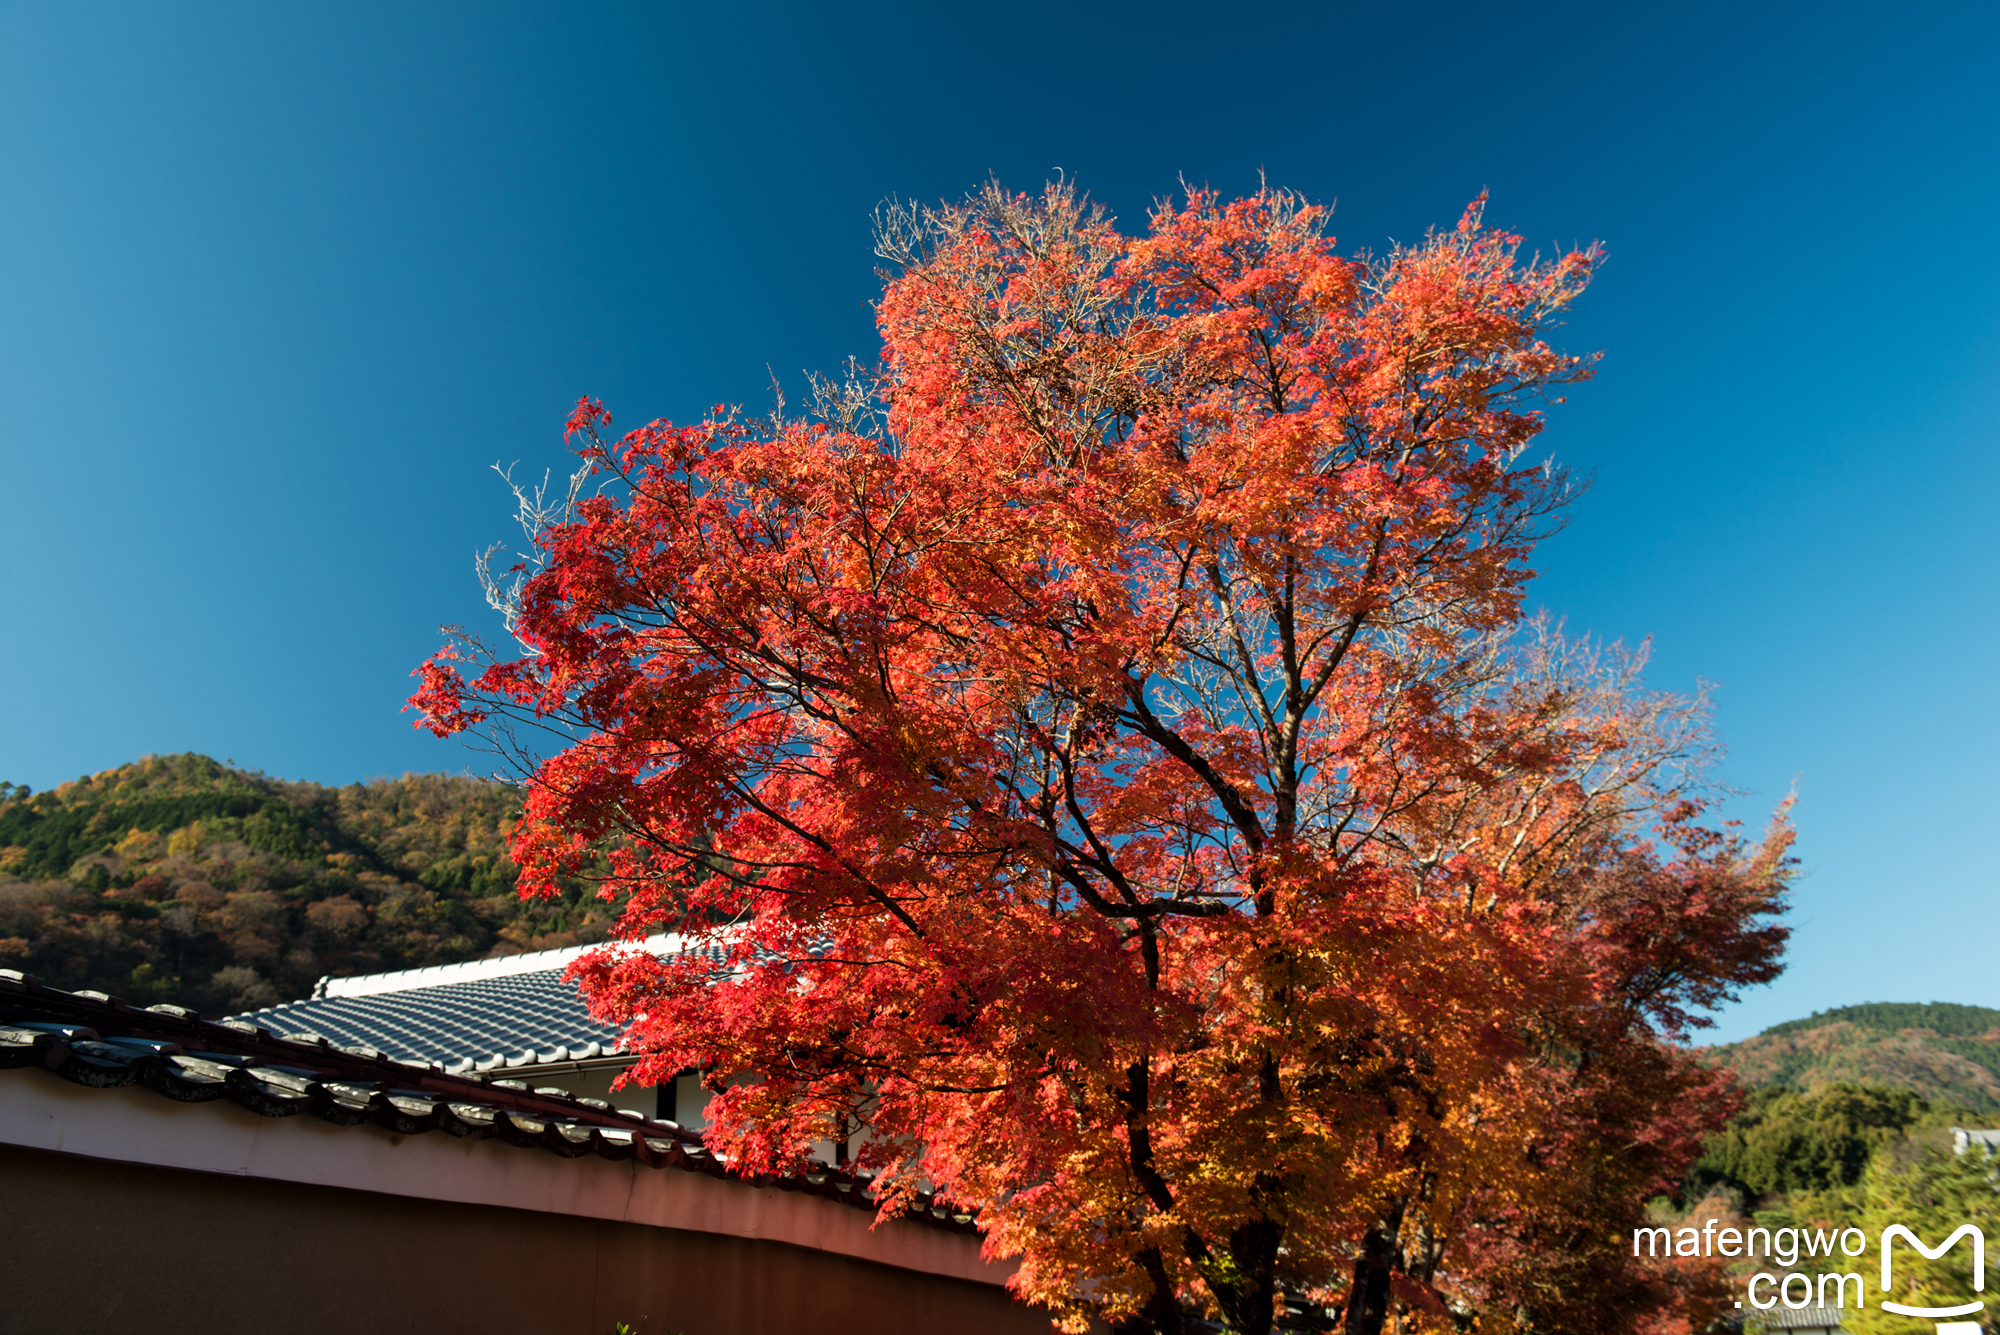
[0,755,612,1015]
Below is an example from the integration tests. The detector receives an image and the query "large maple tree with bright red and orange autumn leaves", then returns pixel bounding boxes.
[414,188,1788,1333]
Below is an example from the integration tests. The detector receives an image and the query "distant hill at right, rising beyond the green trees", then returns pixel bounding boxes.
[1708,1001,2000,1113]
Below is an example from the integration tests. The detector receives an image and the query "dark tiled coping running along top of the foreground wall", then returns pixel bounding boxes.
[0,969,970,1231]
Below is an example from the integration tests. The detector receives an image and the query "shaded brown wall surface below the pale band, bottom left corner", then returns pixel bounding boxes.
[0,1145,1048,1335]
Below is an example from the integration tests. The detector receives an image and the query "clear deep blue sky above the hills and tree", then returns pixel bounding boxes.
[0,2,2000,1037]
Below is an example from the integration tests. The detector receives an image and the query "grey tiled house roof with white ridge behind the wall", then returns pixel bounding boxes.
[238,937,722,1073]
